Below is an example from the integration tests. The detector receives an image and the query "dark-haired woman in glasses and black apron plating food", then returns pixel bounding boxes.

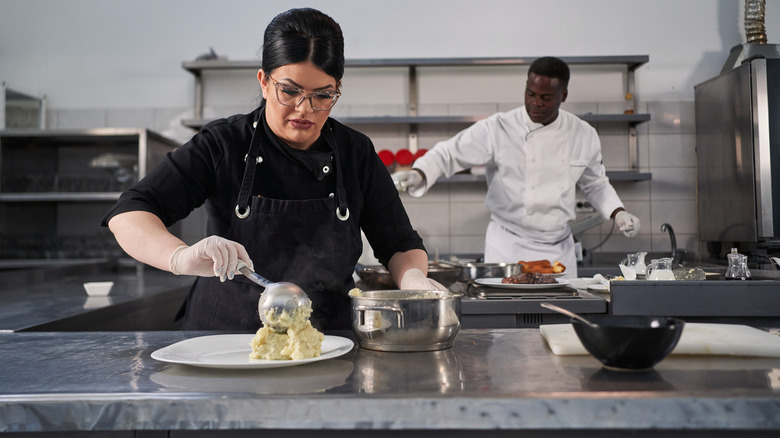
[104,8,444,331]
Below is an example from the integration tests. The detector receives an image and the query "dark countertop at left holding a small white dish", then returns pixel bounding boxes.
[0,261,194,331]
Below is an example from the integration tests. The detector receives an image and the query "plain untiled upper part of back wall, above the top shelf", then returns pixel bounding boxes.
[0,0,780,108]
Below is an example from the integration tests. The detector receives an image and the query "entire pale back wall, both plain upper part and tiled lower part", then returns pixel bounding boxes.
[0,0,780,264]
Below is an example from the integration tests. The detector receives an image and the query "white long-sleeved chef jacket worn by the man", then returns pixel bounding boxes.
[413,106,623,261]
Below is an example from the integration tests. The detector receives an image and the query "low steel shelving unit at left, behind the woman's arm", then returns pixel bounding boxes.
[0,128,180,263]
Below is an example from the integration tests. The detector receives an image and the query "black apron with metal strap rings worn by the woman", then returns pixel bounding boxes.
[182,113,363,331]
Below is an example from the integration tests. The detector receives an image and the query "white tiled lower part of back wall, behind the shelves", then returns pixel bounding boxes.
[48,67,700,264]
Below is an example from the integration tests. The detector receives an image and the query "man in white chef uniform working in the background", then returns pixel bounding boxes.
[393,57,639,277]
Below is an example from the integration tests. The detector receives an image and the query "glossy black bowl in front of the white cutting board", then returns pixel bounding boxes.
[571,315,685,370]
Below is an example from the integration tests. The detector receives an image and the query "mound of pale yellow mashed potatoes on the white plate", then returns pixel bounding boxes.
[249,305,325,360]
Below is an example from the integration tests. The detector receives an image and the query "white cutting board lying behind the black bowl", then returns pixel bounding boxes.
[539,322,780,357]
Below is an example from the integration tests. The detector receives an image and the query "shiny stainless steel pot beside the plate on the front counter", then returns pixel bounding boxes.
[350,290,461,351]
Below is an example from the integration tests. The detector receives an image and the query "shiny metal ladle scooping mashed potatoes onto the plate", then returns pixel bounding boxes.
[237,261,311,332]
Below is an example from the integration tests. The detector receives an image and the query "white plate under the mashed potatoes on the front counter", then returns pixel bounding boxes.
[152,334,355,368]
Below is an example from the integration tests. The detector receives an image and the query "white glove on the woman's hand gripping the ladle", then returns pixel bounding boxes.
[168,236,254,281]
